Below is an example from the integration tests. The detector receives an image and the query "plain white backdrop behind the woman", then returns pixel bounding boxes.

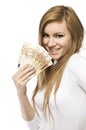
[0,0,86,130]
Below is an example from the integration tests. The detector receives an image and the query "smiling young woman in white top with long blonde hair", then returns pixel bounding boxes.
[12,6,86,130]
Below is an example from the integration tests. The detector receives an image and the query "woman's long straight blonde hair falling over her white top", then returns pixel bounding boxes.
[32,5,84,117]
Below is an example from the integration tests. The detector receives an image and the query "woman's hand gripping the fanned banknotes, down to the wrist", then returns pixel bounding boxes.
[12,65,36,94]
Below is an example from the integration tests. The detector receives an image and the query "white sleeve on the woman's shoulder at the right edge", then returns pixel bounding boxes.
[68,54,86,91]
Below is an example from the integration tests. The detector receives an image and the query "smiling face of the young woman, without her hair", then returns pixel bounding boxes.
[43,20,72,60]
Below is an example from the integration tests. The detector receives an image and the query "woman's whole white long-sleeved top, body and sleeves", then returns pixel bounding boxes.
[26,53,86,130]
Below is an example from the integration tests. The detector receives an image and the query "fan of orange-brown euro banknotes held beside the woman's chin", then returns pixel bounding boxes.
[18,43,53,74]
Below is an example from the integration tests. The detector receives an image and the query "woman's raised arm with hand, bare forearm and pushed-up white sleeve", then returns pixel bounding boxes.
[12,65,51,130]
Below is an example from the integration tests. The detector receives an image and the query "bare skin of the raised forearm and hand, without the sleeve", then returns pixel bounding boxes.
[12,65,35,121]
